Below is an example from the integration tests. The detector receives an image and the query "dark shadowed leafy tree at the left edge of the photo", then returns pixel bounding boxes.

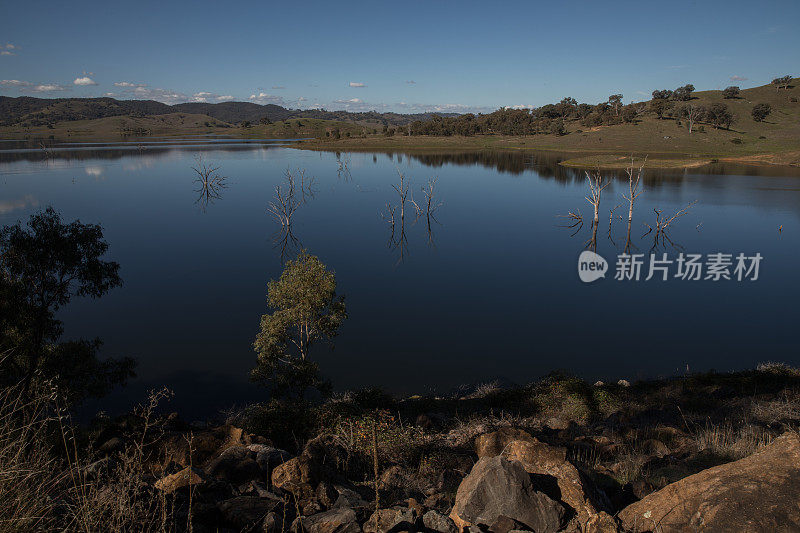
[0,207,133,403]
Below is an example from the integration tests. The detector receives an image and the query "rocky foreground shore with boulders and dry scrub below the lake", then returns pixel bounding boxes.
[78,365,800,533]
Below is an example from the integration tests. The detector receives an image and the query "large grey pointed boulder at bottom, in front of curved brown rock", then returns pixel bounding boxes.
[450,456,565,533]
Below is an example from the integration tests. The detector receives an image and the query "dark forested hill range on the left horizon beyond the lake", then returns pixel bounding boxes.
[0,96,457,126]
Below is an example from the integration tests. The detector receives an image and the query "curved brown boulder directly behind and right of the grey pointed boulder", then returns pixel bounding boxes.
[503,438,609,530]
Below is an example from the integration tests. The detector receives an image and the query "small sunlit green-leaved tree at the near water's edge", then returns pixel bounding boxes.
[252,250,347,399]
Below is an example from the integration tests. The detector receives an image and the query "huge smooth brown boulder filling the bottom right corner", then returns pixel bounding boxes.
[619,433,800,533]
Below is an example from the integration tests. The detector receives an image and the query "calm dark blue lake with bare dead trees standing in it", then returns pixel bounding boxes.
[0,138,800,416]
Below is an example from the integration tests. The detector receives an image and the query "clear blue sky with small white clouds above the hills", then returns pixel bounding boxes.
[0,0,800,112]
